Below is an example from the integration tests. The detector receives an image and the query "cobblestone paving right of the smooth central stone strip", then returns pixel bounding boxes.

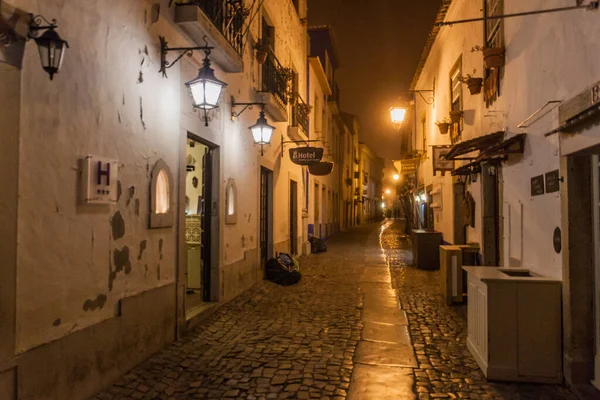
[381,223,575,400]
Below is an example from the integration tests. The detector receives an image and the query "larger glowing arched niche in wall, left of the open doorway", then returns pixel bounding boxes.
[150,159,175,228]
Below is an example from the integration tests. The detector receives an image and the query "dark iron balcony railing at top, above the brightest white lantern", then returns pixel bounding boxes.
[186,0,248,55]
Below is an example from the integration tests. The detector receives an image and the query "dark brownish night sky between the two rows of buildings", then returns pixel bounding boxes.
[308,0,440,159]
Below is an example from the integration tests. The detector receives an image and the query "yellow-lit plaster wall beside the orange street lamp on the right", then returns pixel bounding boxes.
[415,0,490,243]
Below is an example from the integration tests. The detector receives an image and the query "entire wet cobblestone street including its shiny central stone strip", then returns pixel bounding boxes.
[93,223,572,400]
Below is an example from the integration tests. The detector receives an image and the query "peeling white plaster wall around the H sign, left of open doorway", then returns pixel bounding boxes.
[14,0,181,352]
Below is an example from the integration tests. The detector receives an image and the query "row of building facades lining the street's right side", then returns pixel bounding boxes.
[410,0,600,387]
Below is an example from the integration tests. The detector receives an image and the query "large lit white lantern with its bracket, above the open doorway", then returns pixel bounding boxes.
[158,36,227,126]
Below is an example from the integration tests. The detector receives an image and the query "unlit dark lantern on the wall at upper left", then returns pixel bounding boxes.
[29,14,69,80]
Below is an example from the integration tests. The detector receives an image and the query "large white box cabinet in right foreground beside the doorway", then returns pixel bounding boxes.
[463,267,562,383]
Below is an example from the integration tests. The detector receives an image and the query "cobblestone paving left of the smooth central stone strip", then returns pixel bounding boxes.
[94,226,373,400]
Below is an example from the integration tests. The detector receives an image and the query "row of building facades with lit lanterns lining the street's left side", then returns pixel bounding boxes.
[0,0,346,400]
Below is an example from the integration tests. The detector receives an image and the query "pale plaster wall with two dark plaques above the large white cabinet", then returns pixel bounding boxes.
[503,0,600,278]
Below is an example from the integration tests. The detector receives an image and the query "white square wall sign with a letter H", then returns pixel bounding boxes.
[81,155,119,204]
